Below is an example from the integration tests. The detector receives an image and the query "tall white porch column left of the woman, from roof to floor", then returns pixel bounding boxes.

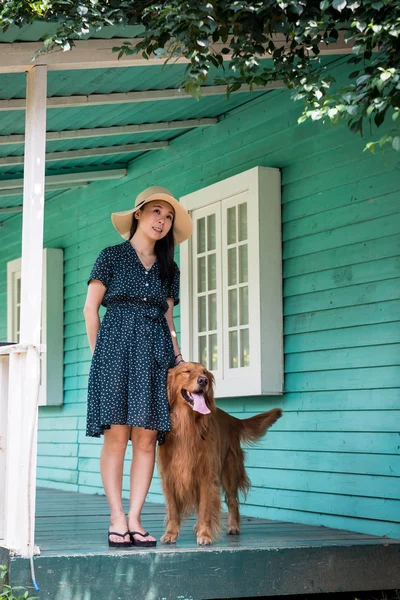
[4,66,47,556]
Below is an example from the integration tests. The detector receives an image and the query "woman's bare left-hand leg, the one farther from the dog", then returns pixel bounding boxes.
[100,425,131,542]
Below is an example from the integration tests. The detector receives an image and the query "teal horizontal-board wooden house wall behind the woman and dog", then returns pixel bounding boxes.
[0,61,400,537]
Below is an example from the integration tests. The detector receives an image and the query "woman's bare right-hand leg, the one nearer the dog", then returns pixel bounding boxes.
[128,427,157,541]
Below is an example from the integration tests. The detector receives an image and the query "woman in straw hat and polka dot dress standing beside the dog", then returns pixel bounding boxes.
[84,187,193,547]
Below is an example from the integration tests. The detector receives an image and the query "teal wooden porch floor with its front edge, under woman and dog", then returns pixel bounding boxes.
[0,489,400,600]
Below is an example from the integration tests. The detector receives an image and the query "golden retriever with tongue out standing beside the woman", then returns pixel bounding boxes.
[157,362,282,545]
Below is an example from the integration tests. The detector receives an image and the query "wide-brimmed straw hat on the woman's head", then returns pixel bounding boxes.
[111,185,193,246]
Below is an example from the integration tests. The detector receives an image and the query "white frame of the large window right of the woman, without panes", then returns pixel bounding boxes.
[180,167,283,397]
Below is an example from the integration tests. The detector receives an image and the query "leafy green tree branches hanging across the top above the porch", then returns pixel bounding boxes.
[0,0,400,151]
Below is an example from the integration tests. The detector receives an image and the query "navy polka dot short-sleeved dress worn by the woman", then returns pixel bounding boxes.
[86,241,180,443]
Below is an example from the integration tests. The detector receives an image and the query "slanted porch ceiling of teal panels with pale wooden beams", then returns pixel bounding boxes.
[0,22,347,226]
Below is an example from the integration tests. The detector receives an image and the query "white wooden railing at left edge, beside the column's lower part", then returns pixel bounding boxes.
[0,344,41,556]
